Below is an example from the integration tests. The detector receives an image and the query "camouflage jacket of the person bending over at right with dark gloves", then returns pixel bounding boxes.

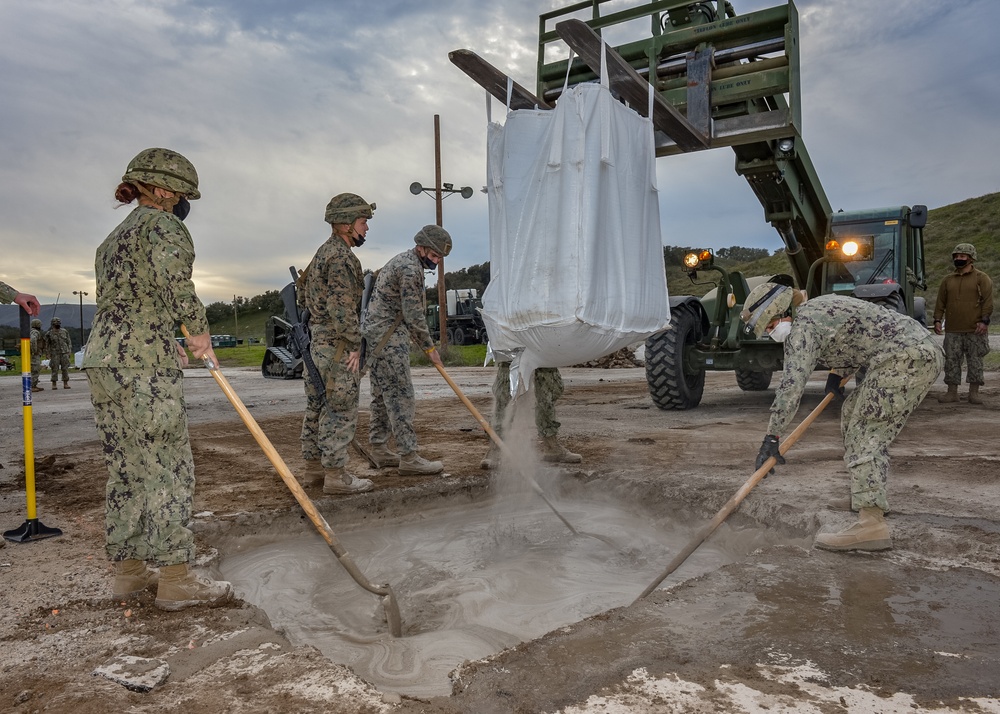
[767,295,940,436]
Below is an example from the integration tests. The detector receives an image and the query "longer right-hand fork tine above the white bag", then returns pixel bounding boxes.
[556,20,711,151]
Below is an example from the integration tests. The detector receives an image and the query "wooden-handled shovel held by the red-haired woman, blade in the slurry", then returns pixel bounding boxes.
[181,325,403,637]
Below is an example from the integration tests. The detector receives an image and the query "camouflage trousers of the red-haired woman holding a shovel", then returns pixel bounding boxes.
[87,367,194,565]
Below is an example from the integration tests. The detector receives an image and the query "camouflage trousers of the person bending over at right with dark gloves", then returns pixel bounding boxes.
[840,336,944,511]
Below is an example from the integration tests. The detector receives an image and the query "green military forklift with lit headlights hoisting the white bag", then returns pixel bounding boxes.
[449,0,927,409]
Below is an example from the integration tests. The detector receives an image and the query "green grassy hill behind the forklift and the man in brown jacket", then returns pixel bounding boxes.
[667,193,1000,314]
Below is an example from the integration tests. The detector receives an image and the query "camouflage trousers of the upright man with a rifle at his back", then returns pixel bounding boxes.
[299,344,360,469]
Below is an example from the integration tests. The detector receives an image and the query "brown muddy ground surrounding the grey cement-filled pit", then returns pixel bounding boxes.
[0,368,1000,714]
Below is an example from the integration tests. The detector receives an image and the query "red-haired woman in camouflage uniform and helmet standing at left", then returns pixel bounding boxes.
[83,148,232,611]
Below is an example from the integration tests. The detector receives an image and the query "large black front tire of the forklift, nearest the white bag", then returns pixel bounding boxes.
[646,303,705,409]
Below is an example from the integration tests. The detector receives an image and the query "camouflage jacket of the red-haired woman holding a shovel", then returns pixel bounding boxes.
[83,206,208,369]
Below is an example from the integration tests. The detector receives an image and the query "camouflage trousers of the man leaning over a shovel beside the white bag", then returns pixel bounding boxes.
[368,336,417,454]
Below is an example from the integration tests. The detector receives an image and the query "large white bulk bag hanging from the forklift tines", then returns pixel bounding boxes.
[482,78,670,389]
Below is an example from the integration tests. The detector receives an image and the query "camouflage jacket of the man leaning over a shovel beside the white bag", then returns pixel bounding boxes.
[365,249,434,351]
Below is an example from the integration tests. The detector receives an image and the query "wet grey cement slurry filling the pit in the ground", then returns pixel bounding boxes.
[221,498,804,697]
